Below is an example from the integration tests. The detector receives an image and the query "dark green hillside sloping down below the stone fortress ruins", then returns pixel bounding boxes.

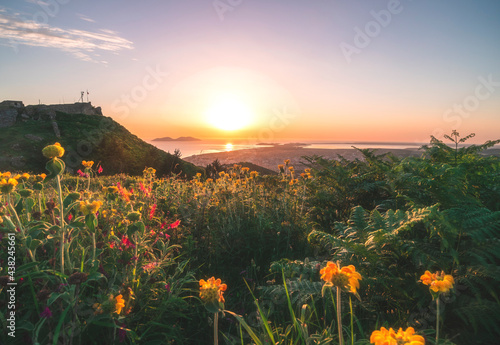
[0,111,200,176]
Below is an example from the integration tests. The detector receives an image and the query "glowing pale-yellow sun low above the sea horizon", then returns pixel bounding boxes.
[205,95,254,131]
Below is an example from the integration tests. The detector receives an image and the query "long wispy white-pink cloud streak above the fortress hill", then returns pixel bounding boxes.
[0,9,134,62]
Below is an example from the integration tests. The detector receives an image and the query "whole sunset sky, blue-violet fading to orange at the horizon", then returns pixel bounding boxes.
[0,0,500,142]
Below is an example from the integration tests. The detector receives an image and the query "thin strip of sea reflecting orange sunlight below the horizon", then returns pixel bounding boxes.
[146,139,424,158]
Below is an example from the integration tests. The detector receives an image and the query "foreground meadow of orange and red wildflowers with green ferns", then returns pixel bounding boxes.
[0,133,500,345]
